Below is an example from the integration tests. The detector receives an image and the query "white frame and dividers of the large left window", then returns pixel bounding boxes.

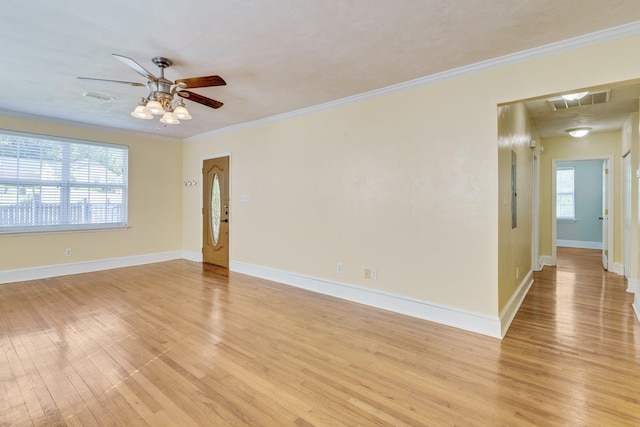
[0,128,130,236]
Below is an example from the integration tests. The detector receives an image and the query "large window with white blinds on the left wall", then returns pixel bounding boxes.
[0,130,128,233]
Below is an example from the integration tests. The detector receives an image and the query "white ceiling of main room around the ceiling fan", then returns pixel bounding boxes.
[0,0,640,139]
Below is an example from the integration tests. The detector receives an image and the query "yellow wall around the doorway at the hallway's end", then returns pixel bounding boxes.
[540,132,623,264]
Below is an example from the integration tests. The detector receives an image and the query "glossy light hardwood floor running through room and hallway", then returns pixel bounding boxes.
[0,248,640,426]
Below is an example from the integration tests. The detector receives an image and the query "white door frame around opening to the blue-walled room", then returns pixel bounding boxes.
[551,154,617,272]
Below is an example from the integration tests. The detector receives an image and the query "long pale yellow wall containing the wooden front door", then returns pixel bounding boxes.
[183,37,640,316]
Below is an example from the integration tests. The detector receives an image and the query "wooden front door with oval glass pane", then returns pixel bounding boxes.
[202,157,229,268]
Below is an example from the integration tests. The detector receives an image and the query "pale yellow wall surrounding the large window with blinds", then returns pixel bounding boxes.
[0,117,182,270]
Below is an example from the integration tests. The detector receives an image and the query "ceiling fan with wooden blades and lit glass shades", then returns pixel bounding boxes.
[78,53,227,124]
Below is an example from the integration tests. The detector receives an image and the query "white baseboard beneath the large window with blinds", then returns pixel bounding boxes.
[0,251,183,284]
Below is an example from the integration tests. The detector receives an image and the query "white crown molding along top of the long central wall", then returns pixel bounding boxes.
[182,21,640,142]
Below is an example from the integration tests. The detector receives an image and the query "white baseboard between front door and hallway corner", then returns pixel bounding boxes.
[230,261,502,338]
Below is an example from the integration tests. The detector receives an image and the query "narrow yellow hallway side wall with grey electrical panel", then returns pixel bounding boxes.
[498,103,540,310]
